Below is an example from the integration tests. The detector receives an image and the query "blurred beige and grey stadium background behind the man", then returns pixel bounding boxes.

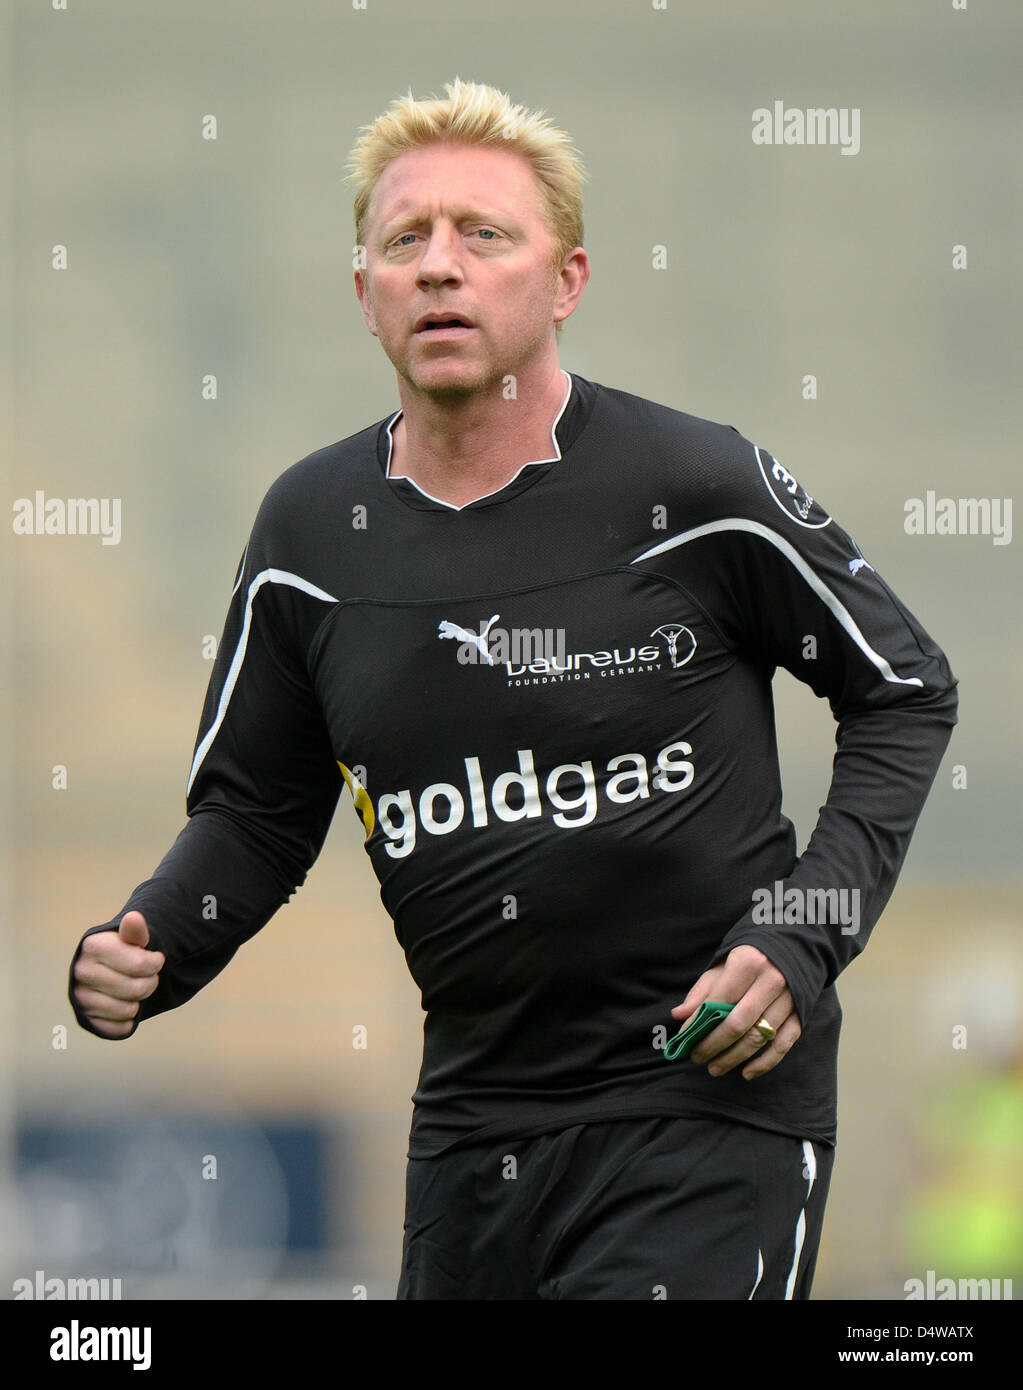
[0,0,1023,1300]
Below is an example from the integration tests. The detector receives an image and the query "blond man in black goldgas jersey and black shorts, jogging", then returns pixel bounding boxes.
[72,73,956,1298]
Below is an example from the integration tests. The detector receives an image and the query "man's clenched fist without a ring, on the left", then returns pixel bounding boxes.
[74,912,165,1038]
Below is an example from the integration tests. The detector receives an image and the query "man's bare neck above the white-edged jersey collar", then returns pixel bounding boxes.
[388,361,568,507]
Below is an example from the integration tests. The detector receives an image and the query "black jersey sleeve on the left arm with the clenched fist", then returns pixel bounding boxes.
[69,478,343,1037]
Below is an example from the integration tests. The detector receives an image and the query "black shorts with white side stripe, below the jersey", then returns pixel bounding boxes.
[398,1118,834,1300]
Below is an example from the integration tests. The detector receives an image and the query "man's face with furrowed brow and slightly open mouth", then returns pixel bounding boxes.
[356,145,585,399]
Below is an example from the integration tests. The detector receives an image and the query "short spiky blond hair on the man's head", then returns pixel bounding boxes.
[346,76,587,276]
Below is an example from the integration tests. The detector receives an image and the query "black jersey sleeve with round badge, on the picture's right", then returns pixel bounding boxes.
[636,432,958,1024]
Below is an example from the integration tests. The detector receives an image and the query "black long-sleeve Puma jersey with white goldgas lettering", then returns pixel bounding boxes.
[76,373,956,1156]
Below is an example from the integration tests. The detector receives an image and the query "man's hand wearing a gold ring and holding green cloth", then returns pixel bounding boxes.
[671,947,802,1081]
